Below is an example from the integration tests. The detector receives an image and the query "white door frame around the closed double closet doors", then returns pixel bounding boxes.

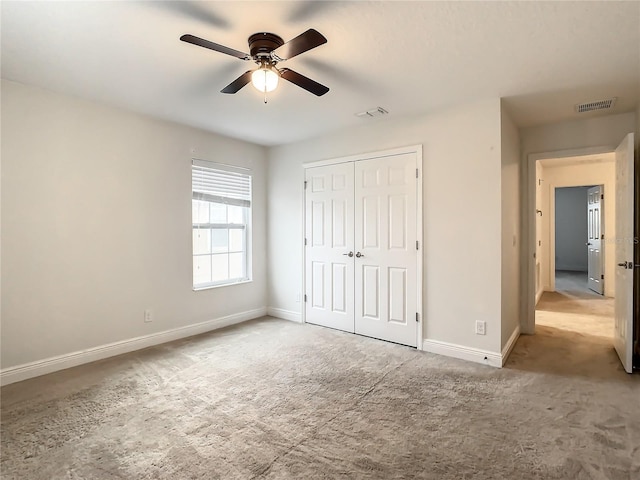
[300,144,426,350]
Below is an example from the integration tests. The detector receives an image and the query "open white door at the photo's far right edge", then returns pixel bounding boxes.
[613,133,634,373]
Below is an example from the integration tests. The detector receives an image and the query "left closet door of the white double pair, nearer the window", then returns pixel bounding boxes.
[305,163,354,332]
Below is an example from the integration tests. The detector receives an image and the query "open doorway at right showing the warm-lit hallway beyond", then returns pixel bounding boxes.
[535,158,615,346]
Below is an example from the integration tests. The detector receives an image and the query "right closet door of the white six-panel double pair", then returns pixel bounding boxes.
[355,153,418,347]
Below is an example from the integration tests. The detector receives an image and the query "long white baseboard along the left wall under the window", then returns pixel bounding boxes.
[0,307,267,385]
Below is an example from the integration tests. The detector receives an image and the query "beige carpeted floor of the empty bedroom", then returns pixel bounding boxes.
[0,318,640,480]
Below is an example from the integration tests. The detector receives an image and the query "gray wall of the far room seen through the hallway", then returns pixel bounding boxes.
[556,187,589,272]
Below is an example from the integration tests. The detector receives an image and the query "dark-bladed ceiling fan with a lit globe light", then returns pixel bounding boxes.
[180,28,329,97]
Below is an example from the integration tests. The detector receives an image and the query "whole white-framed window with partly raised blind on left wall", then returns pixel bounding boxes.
[191,160,251,290]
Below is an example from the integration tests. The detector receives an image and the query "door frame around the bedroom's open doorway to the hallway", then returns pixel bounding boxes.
[520,145,617,335]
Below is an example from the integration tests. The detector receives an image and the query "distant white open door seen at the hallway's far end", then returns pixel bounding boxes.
[583,185,604,295]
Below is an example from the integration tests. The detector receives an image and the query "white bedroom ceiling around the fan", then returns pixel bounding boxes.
[1,0,640,145]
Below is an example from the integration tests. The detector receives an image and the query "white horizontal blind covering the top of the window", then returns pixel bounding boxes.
[191,160,251,207]
